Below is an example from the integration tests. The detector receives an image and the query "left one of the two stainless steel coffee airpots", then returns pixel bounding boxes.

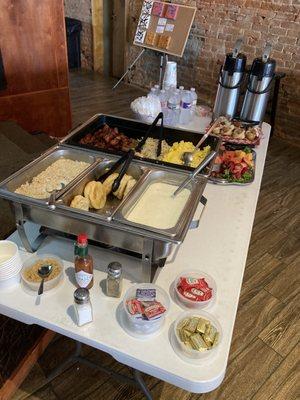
[213,39,247,119]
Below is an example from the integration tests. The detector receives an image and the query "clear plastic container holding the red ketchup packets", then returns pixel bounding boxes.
[174,271,217,309]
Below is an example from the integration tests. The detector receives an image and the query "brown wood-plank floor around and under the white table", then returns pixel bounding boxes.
[14,74,300,400]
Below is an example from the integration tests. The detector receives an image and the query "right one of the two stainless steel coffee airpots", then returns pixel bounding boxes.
[240,43,276,122]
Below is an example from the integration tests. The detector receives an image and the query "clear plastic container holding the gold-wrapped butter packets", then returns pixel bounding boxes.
[172,311,222,363]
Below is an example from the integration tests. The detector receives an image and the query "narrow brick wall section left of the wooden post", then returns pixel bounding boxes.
[64,0,93,69]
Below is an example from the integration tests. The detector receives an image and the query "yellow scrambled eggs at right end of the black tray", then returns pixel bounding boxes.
[162,140,211,168]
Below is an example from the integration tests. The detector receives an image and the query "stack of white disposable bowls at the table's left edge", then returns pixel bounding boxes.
[0,240,22,289]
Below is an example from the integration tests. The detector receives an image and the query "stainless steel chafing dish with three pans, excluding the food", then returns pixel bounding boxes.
[0,115,220,281]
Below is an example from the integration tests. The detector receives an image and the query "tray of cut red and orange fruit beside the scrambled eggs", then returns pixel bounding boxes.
[209,146,256,185]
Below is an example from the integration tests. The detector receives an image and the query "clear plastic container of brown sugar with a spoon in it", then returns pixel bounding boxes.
[21,254,64,292]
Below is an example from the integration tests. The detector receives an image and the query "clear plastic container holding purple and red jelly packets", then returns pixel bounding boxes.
[123,283,170,335]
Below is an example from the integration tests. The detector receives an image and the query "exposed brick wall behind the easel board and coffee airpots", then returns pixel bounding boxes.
[127,0,300,145]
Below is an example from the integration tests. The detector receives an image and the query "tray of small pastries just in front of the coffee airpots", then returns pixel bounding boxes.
[211,117,262,147]
